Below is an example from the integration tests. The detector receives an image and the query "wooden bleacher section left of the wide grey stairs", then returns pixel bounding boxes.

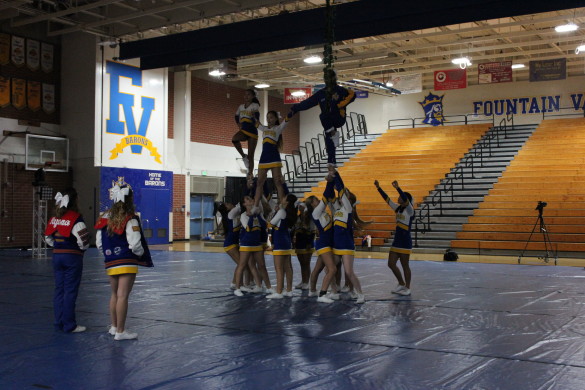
[305,124,490,246]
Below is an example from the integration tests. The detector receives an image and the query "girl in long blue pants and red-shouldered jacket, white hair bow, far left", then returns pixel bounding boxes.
[45,188,89,333]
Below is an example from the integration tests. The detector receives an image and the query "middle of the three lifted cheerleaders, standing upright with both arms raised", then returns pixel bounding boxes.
[254,111,288,211]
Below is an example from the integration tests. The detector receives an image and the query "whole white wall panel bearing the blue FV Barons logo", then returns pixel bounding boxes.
[96,54,167,169]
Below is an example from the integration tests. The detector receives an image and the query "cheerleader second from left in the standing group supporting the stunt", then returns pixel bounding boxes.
[234,196,266,297]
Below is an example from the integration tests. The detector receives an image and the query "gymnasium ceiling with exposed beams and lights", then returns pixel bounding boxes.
[0,0,585,89]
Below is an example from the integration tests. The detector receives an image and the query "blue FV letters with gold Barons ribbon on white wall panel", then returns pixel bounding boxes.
[106,61,162,164]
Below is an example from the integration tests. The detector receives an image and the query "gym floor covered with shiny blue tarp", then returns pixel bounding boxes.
[0,243,585,390]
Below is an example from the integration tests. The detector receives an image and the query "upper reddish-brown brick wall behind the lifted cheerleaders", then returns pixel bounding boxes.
[191,78,299,153]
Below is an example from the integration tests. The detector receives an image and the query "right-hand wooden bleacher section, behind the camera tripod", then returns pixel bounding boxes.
[451,118,585,252]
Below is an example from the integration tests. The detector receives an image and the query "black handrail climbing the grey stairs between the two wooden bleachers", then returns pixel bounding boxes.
[410,113,514,247]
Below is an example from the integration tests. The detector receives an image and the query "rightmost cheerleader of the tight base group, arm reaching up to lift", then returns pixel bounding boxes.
[330,168,367,303]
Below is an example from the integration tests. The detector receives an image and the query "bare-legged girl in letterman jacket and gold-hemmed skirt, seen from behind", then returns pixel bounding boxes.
[95,185,153,340]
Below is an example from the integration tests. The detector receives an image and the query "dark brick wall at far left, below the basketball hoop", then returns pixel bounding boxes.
[0,163,73,248]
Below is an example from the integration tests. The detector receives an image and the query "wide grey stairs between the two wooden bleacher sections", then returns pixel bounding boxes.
[408,125,537,252]
